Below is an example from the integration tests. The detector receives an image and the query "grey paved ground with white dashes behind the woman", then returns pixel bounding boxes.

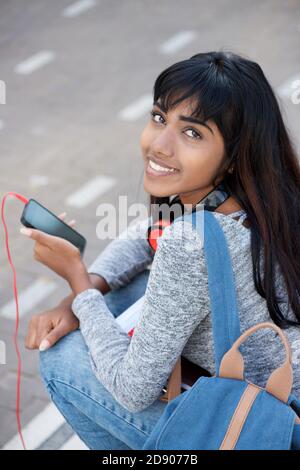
[0,0,300,449]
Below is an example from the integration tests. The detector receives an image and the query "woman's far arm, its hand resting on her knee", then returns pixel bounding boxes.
[25,218,153,349]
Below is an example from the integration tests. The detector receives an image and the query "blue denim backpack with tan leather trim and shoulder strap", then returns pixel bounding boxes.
[143,210,300,450]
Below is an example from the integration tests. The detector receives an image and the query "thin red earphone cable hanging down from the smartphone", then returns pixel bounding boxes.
[1,192,28,450]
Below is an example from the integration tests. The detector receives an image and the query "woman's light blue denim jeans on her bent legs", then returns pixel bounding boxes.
[40,270,167,450]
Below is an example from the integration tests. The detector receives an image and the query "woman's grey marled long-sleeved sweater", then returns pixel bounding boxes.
[72,211,300,412]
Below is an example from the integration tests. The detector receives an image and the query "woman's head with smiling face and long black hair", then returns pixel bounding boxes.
[140,51,300,326]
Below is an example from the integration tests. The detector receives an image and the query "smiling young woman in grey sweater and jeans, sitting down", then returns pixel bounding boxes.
[26,51,300,449]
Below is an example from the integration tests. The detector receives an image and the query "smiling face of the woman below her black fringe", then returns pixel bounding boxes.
[140,100,224,204]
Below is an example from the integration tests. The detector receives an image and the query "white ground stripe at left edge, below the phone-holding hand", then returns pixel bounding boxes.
[0,277,57,320]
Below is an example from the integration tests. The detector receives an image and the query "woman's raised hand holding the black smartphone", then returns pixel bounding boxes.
[20,214,93,295]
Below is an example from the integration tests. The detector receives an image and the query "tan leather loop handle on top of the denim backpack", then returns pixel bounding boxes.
[219,322,293,403]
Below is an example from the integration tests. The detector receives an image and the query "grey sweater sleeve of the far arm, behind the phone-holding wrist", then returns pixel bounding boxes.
[87,217,154,290]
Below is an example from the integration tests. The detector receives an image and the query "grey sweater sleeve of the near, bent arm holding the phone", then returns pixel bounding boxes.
[72,221,207,412]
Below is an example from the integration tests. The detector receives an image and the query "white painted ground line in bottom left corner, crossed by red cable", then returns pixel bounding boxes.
[2,403,65,450]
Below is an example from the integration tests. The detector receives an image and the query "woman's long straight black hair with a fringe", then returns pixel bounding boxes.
[150,50,300,328]
